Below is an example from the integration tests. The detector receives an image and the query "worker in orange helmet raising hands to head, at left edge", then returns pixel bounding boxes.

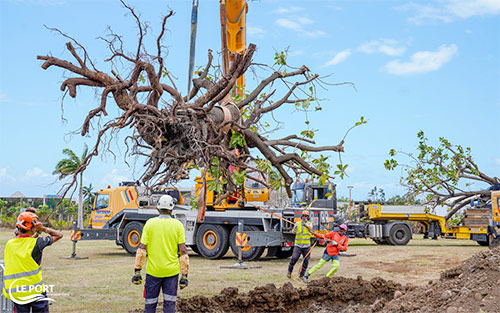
[2,212,63,313]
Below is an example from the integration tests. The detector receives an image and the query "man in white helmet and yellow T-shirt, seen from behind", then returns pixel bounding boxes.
[132,195,189,313]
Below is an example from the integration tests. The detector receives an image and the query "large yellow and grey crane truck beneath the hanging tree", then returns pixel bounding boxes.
[71,178,334,260]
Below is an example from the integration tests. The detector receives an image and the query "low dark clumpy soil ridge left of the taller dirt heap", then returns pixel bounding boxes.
[177,277,411,312]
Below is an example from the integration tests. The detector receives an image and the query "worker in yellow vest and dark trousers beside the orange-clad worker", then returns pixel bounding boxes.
[286,210,312,280]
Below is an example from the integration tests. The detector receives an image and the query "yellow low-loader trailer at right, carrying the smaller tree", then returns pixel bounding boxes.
[347,191,500,247]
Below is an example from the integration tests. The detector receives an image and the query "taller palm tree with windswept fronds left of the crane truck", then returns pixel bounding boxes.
[52,144,89,228]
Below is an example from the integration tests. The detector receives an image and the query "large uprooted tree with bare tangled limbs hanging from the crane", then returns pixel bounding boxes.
[37,2,365,207]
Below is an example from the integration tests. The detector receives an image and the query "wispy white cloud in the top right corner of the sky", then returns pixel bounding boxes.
[401,0,500,24]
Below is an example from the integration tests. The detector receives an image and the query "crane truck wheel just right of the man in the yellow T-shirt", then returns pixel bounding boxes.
[196,224,229,260]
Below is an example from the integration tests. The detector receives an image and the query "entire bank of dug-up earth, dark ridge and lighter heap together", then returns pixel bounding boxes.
[177,248,500,313]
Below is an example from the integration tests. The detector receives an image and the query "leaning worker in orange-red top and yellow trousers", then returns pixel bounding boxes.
[305,224,349,279]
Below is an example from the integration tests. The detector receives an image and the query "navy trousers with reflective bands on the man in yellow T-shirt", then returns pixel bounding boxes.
[144,274,179,313]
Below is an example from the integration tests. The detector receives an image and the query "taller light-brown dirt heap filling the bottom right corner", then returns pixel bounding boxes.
[372,248,500,313]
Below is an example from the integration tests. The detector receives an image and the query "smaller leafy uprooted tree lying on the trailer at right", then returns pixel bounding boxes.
[385,131,500,220]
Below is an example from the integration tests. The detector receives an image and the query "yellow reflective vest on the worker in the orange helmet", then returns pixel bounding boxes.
[2,237,44,304]
